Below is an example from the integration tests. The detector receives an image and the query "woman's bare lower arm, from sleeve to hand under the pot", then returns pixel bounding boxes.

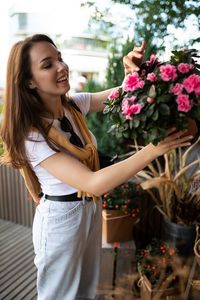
[41,129,192,196]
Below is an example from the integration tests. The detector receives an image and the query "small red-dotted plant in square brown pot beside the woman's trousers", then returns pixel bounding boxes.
[102,181,142,243]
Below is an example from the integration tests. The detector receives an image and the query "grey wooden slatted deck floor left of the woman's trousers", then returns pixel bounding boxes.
[0,220,37,300]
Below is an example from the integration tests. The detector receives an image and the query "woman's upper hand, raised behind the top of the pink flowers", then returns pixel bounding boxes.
[123,42,146,75]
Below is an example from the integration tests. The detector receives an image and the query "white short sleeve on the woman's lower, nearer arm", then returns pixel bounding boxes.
[25,132,57,168]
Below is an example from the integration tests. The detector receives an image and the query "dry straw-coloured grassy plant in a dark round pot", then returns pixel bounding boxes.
[134,137,200,256]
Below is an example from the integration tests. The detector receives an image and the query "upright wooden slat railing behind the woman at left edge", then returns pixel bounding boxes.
[0,166,35,226]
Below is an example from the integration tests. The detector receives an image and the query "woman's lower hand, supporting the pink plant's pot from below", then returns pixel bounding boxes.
[153,128,193,156]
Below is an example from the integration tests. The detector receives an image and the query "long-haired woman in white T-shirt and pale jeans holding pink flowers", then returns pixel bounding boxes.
[1,34,193,300]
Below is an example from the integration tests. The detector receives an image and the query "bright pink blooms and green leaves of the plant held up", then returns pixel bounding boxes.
[104,49,200,145]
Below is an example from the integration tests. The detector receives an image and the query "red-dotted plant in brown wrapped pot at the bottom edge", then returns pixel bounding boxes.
[136,238,189,300]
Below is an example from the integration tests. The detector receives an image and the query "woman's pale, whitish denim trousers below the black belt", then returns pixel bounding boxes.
[33,199,102,300]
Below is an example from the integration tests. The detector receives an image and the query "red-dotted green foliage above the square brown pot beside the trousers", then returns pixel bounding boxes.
[103,182,142,219]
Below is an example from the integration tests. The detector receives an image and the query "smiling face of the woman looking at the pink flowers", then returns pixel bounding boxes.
[29,42,70,101]
